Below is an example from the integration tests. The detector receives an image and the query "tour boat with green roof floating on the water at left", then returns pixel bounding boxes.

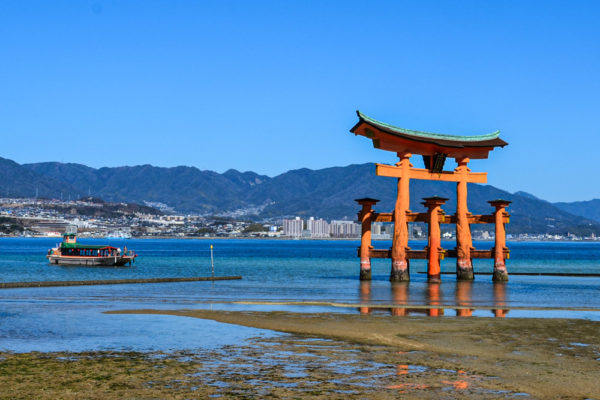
[46,229,137,267]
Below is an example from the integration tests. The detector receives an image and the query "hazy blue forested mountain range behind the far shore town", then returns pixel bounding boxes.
[0,158,600,235]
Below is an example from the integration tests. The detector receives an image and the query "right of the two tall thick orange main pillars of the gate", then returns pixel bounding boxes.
[454,157,473,280]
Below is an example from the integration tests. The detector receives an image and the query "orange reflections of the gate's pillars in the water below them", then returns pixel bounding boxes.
[358,281,509,318]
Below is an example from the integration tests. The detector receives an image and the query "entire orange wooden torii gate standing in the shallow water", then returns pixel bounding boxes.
[350,111,510,282]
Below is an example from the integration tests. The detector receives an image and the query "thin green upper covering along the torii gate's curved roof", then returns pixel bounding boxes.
[350,110,508,147]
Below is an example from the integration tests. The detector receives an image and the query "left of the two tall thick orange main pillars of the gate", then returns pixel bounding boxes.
[390,153,412,282]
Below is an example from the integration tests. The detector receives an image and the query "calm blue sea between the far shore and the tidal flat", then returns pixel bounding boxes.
[0,238,600,351]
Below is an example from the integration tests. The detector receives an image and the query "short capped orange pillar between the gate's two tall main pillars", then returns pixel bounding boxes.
[423,196,448,282]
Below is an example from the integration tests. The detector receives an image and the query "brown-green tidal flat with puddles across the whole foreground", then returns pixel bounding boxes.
[0,310,600,399]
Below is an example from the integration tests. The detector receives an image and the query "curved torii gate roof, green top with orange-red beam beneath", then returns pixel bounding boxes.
[350,111,508,158]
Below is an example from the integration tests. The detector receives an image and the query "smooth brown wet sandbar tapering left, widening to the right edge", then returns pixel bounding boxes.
[108,310,600,398]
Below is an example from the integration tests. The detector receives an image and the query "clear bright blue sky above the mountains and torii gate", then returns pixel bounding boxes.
[0,0,600,201]
